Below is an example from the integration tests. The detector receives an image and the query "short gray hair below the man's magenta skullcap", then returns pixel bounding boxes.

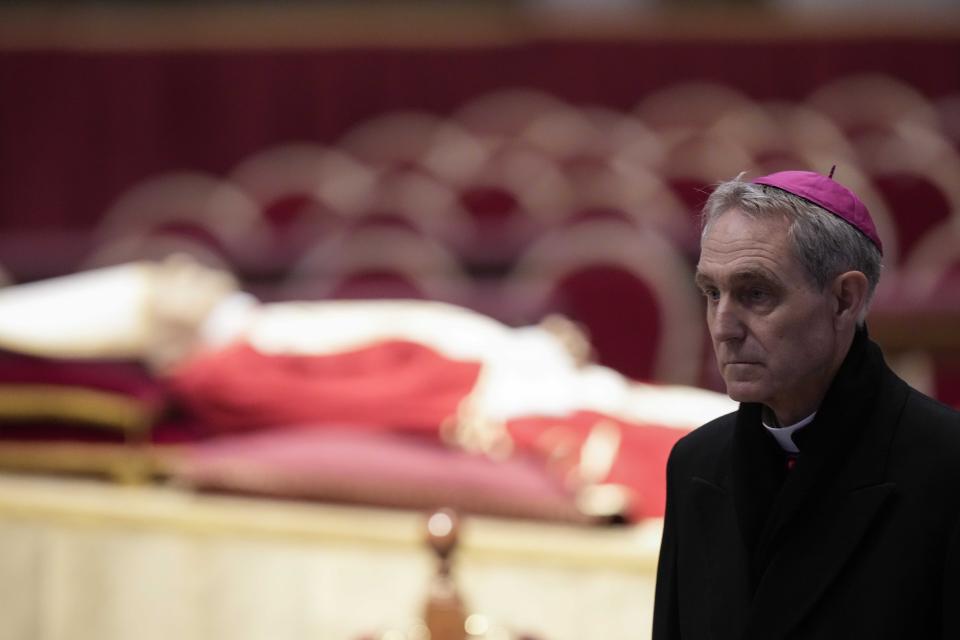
[701,174,881,322]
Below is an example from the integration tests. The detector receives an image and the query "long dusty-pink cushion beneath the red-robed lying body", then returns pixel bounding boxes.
[174,425,587,522]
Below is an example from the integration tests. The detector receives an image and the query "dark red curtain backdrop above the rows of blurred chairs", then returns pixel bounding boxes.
[0,34,960,238]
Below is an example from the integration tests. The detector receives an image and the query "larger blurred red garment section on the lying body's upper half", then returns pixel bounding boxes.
[169,340,480,433]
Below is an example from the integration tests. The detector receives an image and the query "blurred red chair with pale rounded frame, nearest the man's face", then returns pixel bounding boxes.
[505,220,704,384]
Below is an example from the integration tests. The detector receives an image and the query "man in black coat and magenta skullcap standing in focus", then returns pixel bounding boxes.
[653,171,960,640]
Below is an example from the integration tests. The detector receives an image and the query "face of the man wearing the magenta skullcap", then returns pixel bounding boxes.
[696,209,838,424]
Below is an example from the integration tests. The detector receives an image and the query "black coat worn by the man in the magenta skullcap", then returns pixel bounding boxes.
[653,329,960,640]
